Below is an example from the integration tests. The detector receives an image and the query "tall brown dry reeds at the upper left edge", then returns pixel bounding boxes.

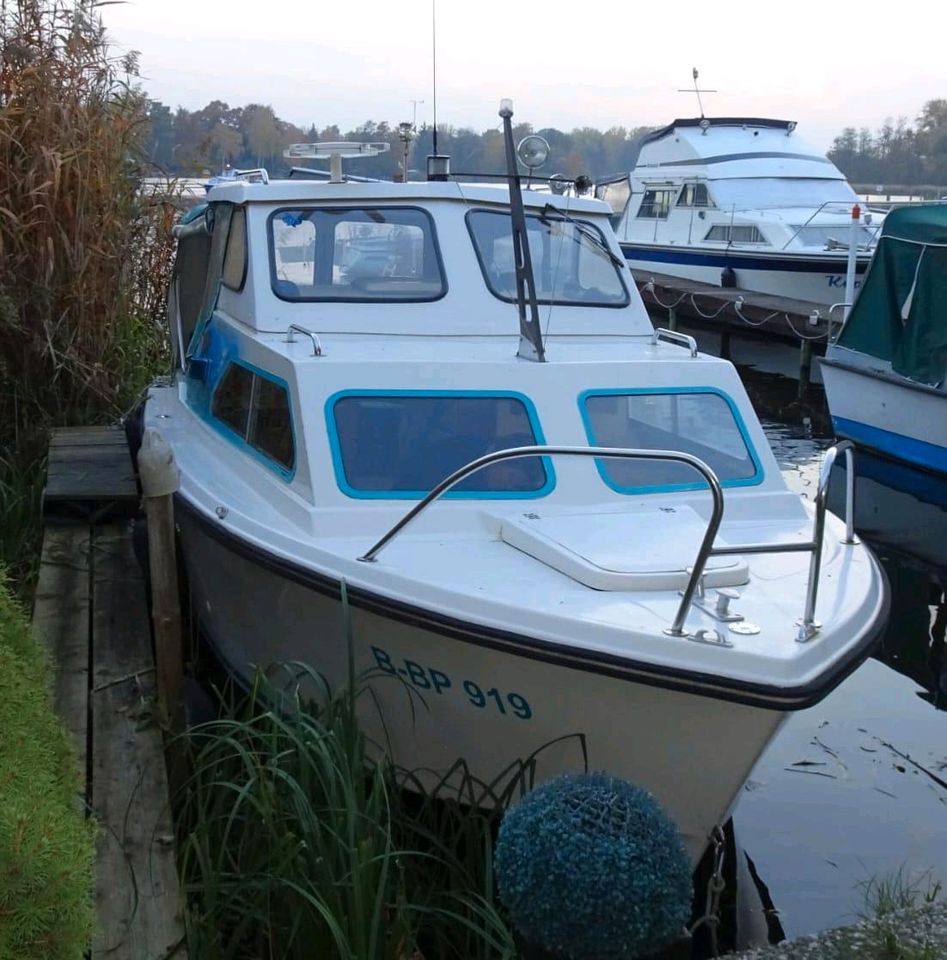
[0,0,174,588]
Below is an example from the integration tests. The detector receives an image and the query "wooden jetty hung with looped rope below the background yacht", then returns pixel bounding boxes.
[632,270,832,343]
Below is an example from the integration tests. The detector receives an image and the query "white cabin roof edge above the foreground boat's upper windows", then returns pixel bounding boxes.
[207,180,611,215]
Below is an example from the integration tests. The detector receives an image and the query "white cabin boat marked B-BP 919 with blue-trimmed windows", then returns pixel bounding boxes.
[144,110,886,860]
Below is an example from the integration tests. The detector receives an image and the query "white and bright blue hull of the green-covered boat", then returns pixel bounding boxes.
[821,356,947,474]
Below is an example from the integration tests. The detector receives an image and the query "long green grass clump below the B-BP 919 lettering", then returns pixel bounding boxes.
[178,664,515,960]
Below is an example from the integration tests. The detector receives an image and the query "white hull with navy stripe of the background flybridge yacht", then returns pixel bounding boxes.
[621,242,868,306]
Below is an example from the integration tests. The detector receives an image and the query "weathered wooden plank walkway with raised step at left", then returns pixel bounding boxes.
[33,427,186,960]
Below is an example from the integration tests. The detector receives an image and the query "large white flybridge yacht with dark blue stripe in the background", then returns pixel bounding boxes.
[595,117,883,306]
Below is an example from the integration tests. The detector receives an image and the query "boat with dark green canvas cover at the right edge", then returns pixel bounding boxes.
[820,203,947,473]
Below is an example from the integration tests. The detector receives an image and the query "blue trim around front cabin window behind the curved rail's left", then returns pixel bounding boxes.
[325,390,556,500]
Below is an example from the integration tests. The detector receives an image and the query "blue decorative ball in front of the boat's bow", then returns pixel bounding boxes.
[495,773,694,960]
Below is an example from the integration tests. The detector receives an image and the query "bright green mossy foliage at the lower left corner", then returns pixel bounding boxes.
[0,569,94,960]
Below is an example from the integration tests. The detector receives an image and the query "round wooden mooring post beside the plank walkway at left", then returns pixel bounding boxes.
[138,427,184,734]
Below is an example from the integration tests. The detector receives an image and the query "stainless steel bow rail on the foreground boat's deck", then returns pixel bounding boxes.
[358,440,858,643]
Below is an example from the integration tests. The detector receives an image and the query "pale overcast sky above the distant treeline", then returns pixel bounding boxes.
[101,0,947,150]
